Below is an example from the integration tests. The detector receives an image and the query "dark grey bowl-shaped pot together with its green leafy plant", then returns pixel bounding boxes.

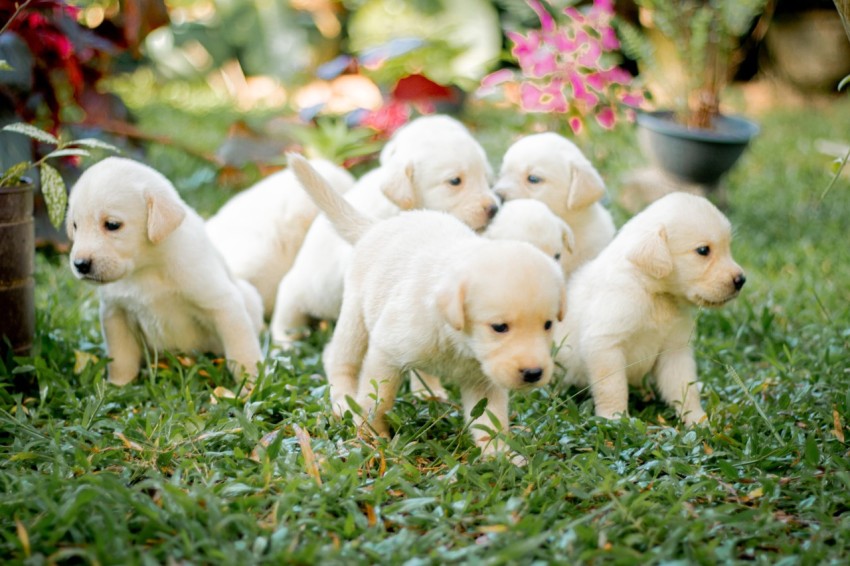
[620,0,767,187]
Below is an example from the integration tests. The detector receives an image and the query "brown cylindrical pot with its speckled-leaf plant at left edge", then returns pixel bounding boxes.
[0,123,117,355]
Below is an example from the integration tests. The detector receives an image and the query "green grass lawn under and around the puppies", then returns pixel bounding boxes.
[0,95,850,564]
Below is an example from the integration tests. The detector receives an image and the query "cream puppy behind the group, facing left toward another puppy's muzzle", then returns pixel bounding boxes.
[494,132,616,274]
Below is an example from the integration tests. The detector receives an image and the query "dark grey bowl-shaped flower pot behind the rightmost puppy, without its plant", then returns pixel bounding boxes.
[637,111,759,187]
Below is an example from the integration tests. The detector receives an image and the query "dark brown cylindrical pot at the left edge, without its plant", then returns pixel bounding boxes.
[0,184,35,356]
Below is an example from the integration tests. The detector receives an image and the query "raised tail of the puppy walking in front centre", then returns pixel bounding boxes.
[287,153,375,244]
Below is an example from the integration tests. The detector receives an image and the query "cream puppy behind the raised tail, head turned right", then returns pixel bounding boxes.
[270,116,498,345]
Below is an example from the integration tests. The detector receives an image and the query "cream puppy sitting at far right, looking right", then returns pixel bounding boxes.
[556,193,746,425]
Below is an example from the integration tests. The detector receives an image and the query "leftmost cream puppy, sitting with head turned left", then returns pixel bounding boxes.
[66,157,262,385]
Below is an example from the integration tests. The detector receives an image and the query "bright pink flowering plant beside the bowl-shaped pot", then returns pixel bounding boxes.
[478,0,643,133]
